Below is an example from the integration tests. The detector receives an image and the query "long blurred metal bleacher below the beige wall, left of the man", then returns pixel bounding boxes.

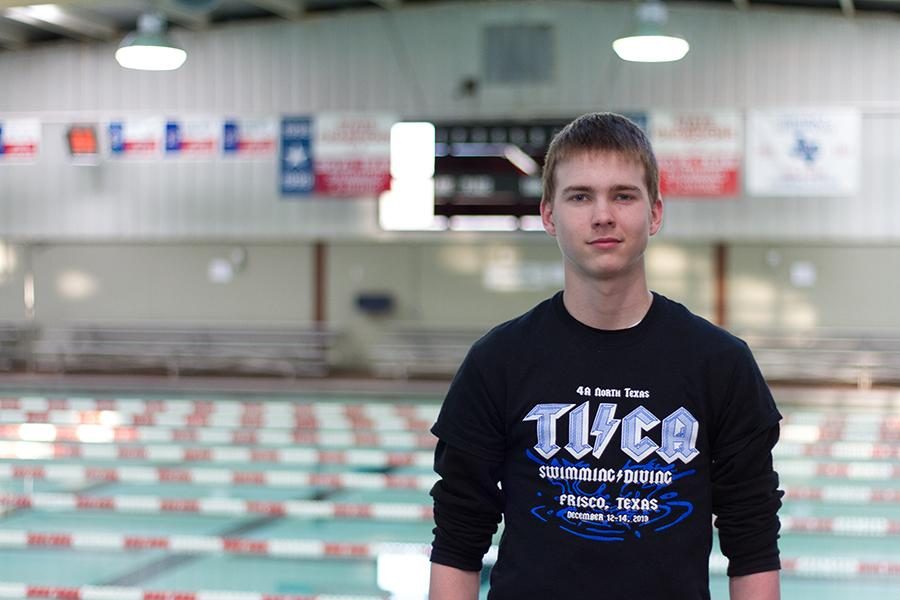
[30,323,336,377]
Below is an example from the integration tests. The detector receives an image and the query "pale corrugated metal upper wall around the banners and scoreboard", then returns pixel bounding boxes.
[0,0,900,240]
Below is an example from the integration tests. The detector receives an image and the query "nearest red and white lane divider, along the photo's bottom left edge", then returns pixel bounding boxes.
[0,582,387,600]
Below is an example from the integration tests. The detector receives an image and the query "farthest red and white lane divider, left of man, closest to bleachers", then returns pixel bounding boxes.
[0,396,440,421]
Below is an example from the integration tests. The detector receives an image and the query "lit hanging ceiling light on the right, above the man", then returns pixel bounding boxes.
[613,0,690,62]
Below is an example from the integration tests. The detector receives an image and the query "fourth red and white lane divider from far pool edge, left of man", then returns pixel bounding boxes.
[0,442,434,469]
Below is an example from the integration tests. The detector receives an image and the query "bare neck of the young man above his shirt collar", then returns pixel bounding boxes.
[563,280,653,331]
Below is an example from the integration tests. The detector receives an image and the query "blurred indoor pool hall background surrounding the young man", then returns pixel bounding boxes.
[0,0,900,600]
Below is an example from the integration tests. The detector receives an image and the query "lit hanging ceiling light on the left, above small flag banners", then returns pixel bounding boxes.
[116,13,187,71]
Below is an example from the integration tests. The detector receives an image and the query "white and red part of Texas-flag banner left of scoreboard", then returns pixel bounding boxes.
[314,114,397,199]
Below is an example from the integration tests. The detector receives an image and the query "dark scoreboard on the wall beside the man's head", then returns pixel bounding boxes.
[434,120,567,217]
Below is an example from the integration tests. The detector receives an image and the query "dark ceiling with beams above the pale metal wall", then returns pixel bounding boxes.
[0,0,900,50]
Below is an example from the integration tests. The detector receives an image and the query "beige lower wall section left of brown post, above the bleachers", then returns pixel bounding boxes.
[31,244,314,325]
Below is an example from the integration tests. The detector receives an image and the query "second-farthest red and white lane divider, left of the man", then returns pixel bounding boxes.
[0,410,434,431]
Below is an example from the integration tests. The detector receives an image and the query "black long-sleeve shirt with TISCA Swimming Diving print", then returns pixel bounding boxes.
[431,294,781,600]
